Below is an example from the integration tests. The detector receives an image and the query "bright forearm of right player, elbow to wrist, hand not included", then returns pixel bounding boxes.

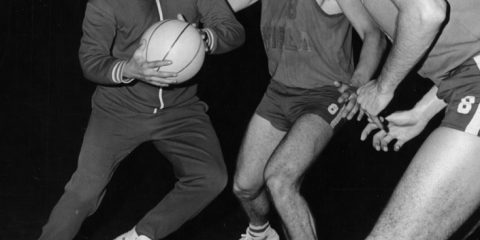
[378,0,446,92]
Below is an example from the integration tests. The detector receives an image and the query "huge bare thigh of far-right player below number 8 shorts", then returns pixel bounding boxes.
[367,127,480,240]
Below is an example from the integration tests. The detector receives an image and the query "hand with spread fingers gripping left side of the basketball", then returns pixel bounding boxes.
[123,39,177,87]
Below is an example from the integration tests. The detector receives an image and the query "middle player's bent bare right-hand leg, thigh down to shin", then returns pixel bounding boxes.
[265,114,333,240]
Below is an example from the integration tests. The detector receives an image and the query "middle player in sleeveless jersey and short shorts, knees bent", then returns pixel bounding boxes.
[229,0,385,240]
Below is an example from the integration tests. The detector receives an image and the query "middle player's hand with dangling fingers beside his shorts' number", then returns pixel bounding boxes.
[334,81,363,121]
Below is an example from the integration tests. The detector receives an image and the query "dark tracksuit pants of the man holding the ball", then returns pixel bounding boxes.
[40,101,227,240]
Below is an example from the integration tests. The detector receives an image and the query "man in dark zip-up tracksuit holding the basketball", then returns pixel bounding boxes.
[40,0,244,240]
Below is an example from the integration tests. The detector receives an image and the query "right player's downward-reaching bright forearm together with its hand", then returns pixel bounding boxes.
[357,0,446,116]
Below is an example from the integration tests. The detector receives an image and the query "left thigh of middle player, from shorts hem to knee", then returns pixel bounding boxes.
[235,114,286,189]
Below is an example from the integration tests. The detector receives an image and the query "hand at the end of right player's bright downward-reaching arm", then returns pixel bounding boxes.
[357,80,394,116]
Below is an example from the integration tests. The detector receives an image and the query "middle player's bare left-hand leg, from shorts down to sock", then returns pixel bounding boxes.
[233,114,285,226]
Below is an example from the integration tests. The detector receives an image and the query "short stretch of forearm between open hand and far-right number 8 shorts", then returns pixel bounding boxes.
[412,86,447,121]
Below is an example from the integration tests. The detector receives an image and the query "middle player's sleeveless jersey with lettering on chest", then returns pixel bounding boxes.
[261,0,353,89]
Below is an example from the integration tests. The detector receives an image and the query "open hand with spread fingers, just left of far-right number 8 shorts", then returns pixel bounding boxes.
[360,110,428,152]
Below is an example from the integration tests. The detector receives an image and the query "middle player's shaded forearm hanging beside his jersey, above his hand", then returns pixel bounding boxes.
[352,30,386,86]
